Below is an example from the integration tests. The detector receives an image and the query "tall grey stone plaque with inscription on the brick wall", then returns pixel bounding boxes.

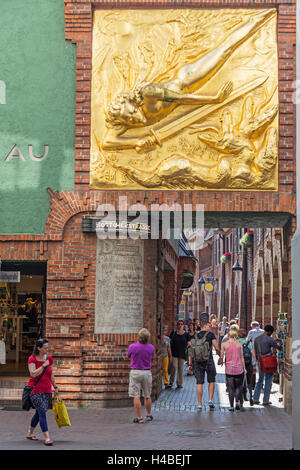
[95,239,144,334]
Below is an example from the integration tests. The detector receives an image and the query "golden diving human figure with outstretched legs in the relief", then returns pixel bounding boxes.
[102,10,274,151]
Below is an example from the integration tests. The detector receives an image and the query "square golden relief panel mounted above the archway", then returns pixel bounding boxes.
[91,9,278,190]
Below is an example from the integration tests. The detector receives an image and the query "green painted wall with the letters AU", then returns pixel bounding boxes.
[0,0,76,234]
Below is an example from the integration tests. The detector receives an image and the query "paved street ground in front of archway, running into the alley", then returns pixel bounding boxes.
[0,356,292,451]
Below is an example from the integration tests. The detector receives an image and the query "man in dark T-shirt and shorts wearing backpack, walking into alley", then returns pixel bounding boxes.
[188,320,220,411]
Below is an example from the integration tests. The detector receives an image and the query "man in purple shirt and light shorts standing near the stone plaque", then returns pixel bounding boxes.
[127,328,154,423]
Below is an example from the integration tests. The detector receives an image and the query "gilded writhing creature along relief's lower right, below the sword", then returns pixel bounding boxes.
[107,95,278,189]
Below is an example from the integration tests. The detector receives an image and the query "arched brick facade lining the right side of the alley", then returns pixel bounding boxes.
[192,224,294,411]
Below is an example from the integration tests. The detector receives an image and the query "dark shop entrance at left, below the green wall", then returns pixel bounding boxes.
[0,261,47,376]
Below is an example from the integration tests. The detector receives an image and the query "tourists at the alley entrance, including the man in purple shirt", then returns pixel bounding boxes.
[128,314,282,423]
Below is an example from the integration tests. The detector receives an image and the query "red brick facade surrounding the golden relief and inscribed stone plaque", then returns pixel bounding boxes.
[0,0,296,405]
